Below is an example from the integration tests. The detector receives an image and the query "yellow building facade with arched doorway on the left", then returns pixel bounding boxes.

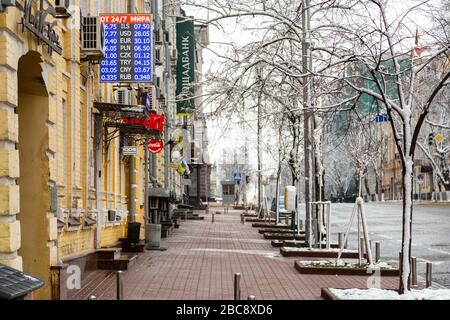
[0,0,153,299]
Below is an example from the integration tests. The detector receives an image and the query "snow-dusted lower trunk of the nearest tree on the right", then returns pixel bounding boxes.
[399,156,414,294]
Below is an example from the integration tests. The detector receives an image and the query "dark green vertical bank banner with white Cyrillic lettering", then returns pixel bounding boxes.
[176,17,195,116]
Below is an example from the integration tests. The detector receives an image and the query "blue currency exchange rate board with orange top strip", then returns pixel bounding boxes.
[100,14,153,82]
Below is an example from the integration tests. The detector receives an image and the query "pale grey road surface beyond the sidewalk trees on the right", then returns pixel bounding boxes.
[301,202,450,288]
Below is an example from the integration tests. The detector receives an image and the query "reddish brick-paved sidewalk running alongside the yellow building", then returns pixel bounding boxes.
[68,210,398,300]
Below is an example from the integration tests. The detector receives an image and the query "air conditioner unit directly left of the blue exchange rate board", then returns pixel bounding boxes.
[81,17,105,61]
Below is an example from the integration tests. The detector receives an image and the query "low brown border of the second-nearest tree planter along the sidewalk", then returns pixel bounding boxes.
[295,261,400,277]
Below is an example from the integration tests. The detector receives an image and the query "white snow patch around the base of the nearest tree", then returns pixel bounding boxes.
[330,288,450,300]
